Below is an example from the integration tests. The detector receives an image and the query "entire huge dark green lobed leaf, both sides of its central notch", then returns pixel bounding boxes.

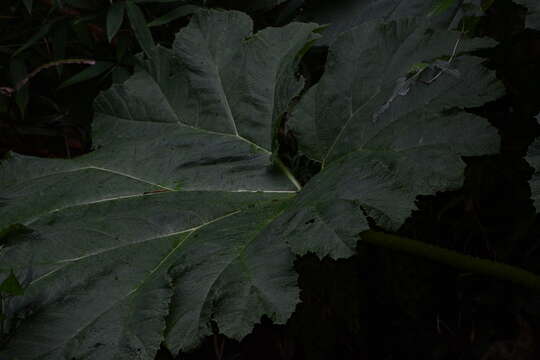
[0,8,506,360]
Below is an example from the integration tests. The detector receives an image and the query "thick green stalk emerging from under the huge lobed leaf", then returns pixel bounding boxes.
[360,230,540,291]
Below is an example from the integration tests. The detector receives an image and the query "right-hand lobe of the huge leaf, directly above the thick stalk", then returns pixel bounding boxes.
[280,19,502,257]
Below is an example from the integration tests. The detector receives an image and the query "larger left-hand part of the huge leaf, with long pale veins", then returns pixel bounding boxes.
[0,11,318,360]
